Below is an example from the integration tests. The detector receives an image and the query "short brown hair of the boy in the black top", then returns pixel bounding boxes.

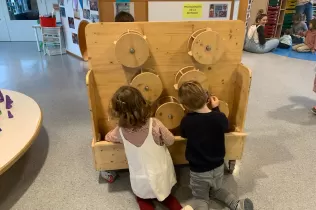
[178,81,208,111]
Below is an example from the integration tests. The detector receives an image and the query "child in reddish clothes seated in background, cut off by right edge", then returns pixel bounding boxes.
[293,19,316,53]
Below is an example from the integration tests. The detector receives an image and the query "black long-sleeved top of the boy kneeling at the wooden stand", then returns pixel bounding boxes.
[180,107,228,172]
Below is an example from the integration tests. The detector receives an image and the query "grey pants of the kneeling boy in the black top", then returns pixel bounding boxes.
[190,165,238,210]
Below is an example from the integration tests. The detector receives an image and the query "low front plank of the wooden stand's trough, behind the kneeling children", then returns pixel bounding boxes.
[92,132,246,171]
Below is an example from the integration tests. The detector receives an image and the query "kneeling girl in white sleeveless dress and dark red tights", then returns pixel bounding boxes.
[105,86,182,210]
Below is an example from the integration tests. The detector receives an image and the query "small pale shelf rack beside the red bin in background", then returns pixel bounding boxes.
[42,27,66,55]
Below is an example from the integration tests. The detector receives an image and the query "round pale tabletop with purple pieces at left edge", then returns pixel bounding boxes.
[0,89,42,175]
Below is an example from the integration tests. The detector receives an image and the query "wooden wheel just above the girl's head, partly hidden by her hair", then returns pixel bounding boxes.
[131,71,163,102]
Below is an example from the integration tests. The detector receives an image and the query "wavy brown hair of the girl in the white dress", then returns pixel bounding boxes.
[109,86,151,128]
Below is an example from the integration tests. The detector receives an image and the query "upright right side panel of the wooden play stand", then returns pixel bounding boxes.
[230,64,251,132]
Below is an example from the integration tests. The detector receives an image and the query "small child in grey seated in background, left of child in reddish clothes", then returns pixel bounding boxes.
[291,14,308,44]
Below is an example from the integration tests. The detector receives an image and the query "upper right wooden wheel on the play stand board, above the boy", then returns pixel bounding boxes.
[188,28,225,65]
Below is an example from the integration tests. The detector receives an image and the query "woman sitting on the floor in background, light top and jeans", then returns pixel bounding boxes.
[244,10,279,53]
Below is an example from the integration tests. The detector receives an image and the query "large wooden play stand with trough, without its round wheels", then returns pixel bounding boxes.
[86,21,251,170]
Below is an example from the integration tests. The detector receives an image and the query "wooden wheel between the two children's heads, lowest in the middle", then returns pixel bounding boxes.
[155,96,184,130]
